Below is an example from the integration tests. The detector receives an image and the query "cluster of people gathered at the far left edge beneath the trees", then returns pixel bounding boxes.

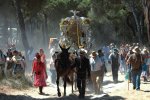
[0,48,26,77]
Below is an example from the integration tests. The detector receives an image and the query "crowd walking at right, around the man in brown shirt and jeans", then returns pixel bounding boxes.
[101,43,150,90]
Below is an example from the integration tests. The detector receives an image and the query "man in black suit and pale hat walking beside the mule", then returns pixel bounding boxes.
[76,50,91,98]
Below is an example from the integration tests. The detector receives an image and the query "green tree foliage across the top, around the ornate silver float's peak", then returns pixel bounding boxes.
[9,0,145,43]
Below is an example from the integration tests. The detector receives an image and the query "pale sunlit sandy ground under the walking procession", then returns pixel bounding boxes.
[0,73,150,100]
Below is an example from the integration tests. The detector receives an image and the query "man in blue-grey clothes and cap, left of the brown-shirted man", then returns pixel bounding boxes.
[109,48,120,83]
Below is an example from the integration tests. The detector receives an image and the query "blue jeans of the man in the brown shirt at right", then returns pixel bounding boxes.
[131,70,141,89]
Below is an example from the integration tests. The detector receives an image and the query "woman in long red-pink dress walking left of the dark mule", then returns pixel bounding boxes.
[32,54,47,94]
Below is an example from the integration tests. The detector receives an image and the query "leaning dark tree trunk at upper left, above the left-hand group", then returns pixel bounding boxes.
[13,0,29,54]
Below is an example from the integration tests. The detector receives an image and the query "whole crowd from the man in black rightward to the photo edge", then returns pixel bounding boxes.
[50,43,150,98]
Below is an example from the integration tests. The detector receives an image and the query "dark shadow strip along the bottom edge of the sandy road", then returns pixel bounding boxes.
[0,93,125,100]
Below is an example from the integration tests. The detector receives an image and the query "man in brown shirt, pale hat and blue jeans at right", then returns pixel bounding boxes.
[127,46,143,90]
